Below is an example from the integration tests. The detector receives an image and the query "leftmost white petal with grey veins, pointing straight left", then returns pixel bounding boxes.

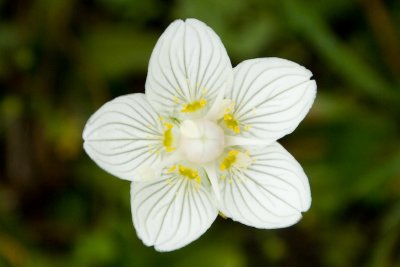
[83,94,163,181]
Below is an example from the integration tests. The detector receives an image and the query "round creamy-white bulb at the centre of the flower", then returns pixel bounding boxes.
[180,119,225,163]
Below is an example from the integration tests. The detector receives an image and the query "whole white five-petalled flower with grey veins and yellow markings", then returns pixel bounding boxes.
[83,19,316,251]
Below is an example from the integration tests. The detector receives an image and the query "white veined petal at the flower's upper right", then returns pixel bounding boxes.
[228,58,316,140]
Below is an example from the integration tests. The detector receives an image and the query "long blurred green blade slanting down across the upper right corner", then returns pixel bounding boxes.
[282,0,400,108]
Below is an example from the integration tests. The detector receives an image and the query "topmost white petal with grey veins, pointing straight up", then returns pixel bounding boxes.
[146,19,233,117]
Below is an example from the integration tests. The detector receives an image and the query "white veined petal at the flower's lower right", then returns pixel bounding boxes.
[220,142,311,229]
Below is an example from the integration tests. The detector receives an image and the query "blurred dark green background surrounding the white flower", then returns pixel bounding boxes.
[0,0,400,267]
